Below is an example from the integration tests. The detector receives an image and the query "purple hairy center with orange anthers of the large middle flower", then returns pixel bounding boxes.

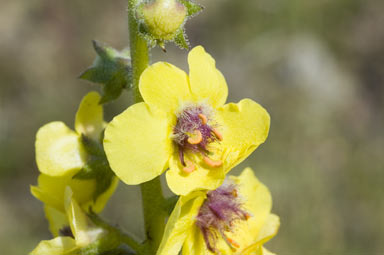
[172,104,223,173]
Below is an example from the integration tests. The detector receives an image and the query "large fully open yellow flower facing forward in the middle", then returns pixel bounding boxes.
[104,46,270,195]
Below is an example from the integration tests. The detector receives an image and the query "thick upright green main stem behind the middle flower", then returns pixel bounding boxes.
[128,0,166,254]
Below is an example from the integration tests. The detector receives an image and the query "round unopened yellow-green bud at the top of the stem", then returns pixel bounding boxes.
[140,0,187,41]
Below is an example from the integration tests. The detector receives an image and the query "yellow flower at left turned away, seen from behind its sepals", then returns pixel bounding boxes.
[31,92,118,213]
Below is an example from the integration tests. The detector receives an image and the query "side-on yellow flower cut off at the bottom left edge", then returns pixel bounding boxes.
[30,186,103,255]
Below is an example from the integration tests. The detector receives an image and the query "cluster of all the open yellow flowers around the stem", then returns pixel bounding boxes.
[31,46,279,255]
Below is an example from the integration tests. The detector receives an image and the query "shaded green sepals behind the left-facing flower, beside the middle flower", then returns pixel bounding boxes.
[72,135,115,201]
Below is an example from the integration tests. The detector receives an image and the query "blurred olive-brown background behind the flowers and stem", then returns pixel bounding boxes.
[0,0,384,255]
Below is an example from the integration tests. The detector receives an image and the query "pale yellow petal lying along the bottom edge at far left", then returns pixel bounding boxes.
[30,236,77,255]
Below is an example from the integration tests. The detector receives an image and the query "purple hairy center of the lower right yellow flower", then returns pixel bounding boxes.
[196,180,250,253]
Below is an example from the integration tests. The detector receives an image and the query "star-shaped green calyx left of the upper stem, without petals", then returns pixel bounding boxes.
[79,40,132,104]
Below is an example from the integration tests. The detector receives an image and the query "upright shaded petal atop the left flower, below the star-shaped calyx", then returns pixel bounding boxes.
[75,91,104,140]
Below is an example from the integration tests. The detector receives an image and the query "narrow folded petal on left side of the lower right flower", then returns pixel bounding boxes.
[156,192,205,255]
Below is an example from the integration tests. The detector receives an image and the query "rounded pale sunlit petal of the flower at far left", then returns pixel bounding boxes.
[35,122,86,176]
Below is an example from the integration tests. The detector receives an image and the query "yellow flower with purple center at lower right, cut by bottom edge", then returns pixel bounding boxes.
[157,168,280,255]
